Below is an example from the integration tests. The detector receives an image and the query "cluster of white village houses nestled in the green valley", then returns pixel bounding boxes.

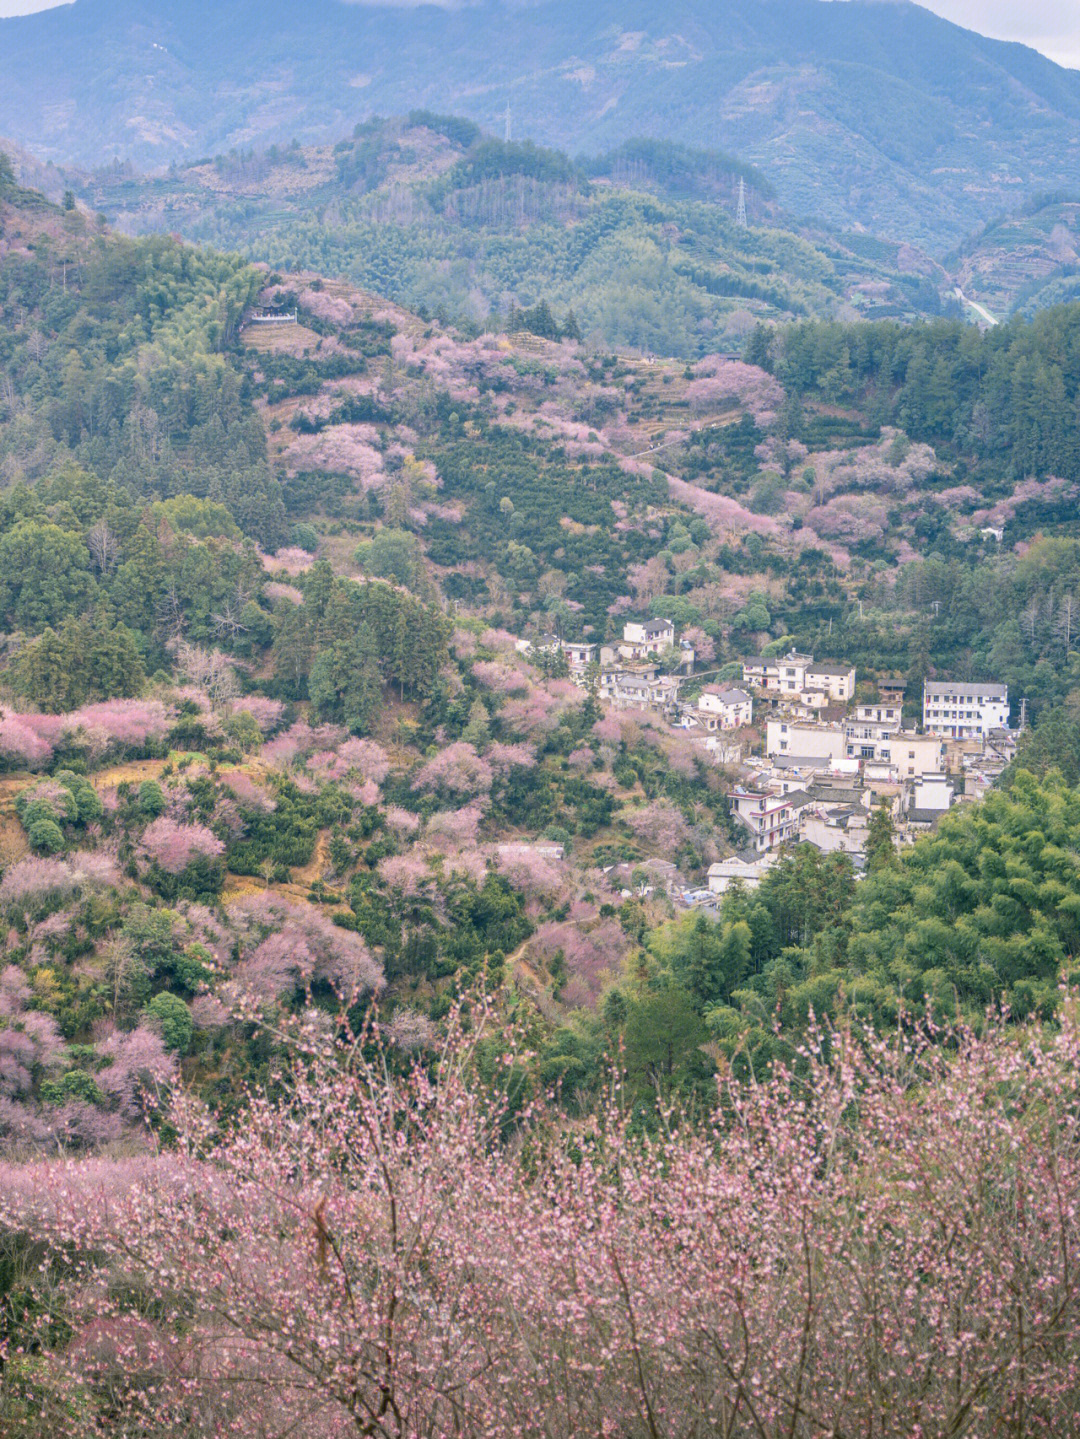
[519,617,1017,909]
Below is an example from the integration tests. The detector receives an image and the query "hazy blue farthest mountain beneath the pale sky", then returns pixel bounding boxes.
[0,0,1080,249]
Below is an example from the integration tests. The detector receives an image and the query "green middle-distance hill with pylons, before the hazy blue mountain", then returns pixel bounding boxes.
[48,111,951,357]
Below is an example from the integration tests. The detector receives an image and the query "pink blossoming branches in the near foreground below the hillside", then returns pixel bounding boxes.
[0,1004,1080,1439]
